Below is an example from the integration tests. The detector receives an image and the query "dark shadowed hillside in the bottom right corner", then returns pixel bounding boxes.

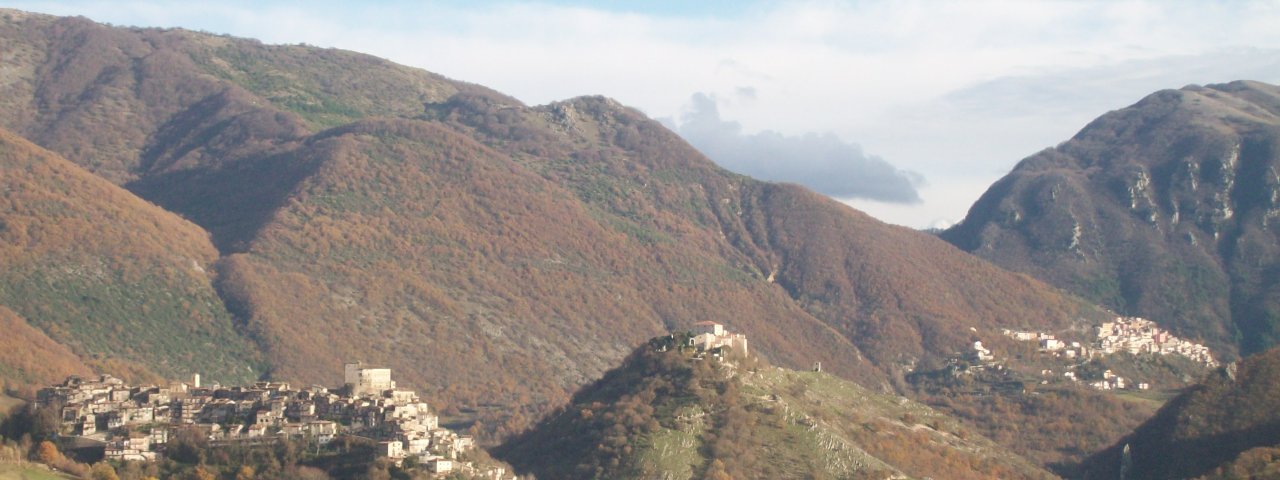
[1085,348,1280,479]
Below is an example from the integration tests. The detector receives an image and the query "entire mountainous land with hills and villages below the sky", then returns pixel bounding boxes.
[0,9,1280,479]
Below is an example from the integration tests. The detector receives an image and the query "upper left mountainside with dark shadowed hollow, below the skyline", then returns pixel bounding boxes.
[0,9,476,252]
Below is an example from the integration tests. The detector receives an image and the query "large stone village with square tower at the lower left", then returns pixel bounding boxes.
[36,364,509,479]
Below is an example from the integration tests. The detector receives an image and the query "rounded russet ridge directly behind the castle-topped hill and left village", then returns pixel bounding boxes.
[223,120,876,422]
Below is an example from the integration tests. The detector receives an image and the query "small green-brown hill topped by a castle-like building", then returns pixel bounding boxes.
[494,335,1053,479]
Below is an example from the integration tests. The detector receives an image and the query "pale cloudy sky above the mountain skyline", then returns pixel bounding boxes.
[17,0,1280,228]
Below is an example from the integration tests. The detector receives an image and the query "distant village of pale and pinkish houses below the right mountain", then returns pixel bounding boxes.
[988,316,1219,390]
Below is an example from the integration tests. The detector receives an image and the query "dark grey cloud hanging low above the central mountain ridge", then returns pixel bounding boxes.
[664,90,924,204]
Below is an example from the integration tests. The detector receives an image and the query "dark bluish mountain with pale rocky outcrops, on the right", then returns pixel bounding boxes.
[942,82,1280,358]
